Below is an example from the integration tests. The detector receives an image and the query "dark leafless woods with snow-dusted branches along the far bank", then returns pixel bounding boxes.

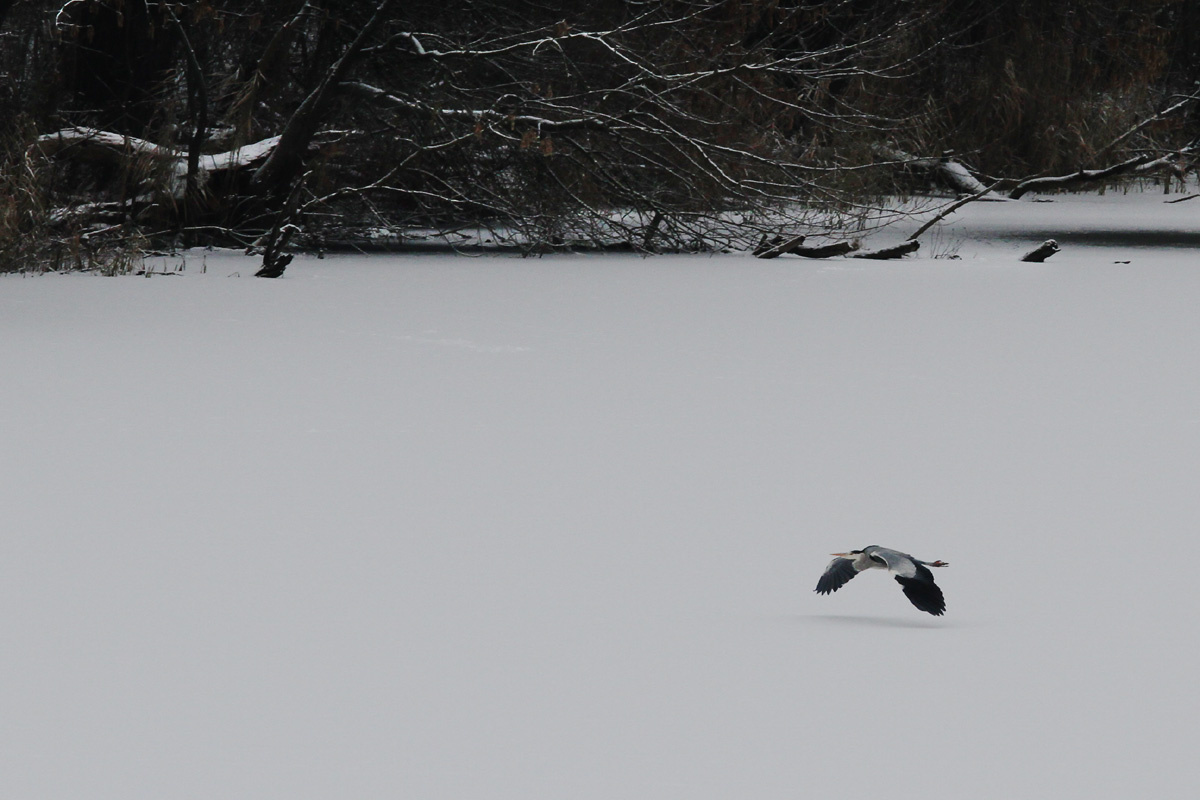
[0,0,1200,272]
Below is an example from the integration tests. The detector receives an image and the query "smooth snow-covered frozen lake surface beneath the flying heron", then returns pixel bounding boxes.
[0,190,1200,800]
